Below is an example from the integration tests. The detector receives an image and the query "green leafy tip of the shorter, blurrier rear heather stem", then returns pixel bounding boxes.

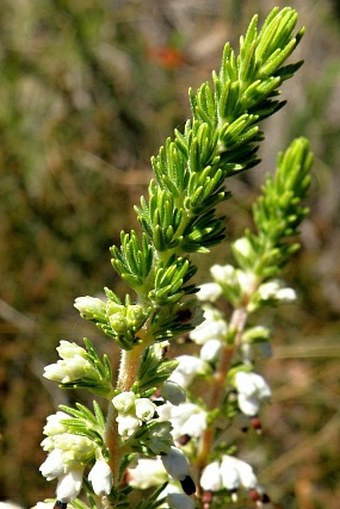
[232,138,313,278]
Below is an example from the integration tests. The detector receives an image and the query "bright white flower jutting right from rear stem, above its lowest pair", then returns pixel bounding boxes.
[234,371,271,417]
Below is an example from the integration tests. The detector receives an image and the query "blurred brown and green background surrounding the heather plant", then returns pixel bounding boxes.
[0,0,340,509]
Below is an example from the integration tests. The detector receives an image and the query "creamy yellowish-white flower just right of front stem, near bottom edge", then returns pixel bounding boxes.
[128,458,168,490]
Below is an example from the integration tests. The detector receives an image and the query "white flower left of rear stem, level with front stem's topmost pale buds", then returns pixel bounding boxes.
[189,306,228,345]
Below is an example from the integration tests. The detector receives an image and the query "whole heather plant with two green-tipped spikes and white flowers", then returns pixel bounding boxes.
[37,7,312,509]
